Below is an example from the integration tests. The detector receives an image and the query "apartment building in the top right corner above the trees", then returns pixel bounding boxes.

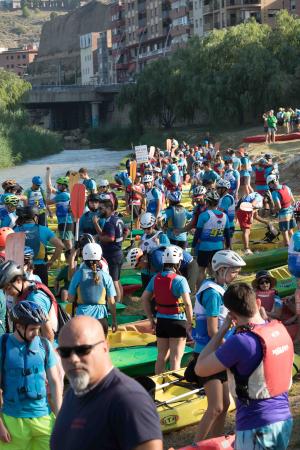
[193,0,300,36]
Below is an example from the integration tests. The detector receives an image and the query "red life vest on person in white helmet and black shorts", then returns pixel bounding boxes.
[154,273,184,315]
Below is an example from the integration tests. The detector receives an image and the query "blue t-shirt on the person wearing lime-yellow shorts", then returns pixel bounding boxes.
[0,334,57,418]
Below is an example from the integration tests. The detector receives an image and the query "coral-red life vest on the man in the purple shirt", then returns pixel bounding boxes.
[229,320,294,400]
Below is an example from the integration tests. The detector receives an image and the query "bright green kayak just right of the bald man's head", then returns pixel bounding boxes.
[110,346,193,377]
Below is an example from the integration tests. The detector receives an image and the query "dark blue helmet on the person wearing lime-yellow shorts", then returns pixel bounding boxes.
[10,300,48,325]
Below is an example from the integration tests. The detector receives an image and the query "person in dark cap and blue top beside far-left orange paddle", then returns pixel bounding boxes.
[14,206,64,285]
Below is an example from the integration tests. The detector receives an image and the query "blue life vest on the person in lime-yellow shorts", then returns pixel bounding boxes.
[1,334,49,414]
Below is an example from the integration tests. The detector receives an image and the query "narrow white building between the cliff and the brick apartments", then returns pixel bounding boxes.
[79,33,99,84]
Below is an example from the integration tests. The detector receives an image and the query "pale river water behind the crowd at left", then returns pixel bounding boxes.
[0,148,129,188]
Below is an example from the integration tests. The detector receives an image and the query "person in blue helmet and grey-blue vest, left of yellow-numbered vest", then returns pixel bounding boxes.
[160,191,192,248]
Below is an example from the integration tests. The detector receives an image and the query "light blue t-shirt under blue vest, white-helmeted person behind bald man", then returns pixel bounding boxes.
[68,265,117,319]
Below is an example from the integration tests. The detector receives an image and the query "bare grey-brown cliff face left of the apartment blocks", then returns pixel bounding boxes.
[29,0,109,85]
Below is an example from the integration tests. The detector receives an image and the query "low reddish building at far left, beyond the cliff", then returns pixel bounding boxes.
[0,44,38,77]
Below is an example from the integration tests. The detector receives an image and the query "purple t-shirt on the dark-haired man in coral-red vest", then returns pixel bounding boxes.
[216,332,291,431]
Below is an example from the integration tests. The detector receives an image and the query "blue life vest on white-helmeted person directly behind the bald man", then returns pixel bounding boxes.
[77,265,106,305]
